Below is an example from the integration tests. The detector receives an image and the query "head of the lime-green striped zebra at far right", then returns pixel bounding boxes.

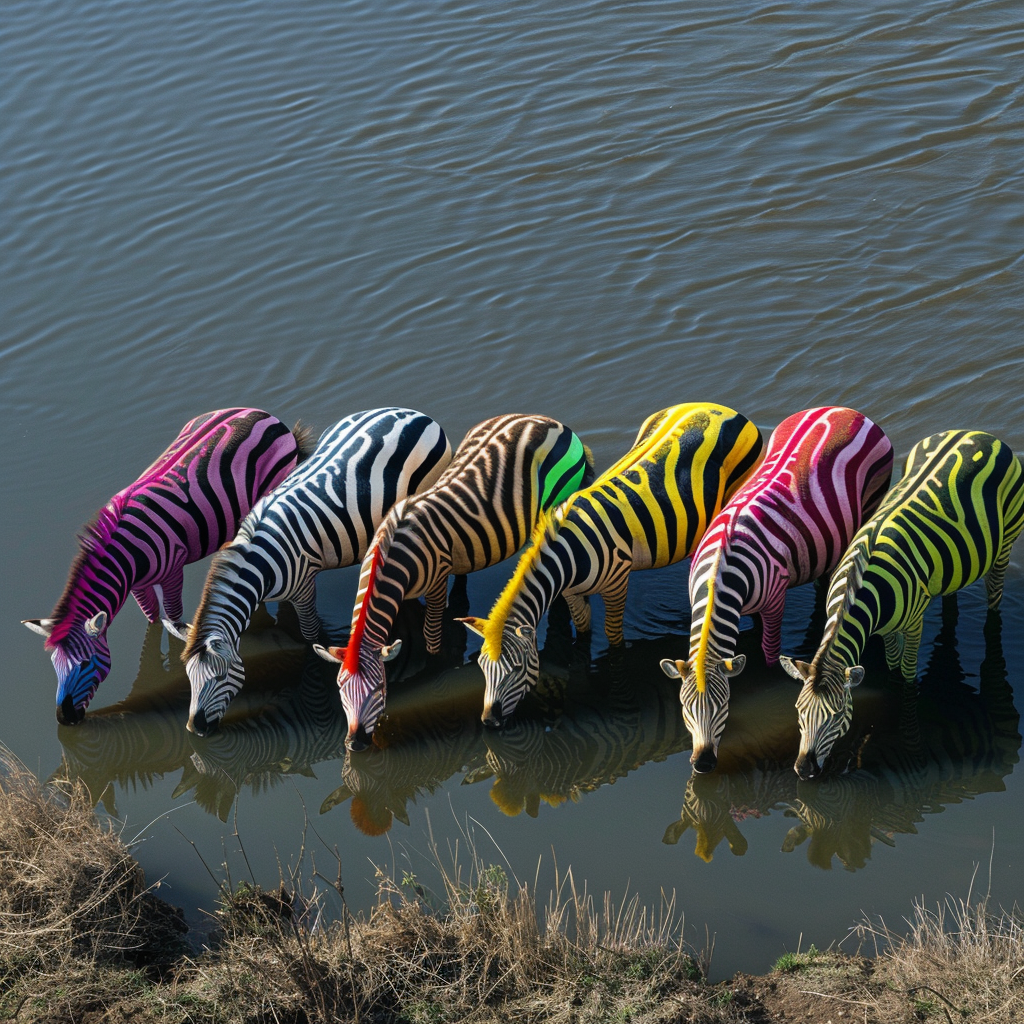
[779,654,864,781]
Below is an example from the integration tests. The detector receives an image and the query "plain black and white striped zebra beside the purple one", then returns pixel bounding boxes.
[181,409,452,736]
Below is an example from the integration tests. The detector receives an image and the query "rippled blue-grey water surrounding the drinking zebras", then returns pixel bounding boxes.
[0,0,1024,973]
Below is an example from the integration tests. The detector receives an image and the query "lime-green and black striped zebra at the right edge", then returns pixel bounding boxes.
[781,430,1024,779]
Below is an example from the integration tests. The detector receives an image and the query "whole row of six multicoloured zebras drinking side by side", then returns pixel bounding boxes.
[26,402,1024,779]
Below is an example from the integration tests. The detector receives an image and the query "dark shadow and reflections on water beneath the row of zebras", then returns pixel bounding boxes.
[55,584,1021,871]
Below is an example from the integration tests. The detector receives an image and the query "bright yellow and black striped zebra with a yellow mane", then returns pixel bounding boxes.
[462,402,761,727]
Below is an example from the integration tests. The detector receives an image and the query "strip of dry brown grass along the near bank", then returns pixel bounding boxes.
[0,754,1024,1024]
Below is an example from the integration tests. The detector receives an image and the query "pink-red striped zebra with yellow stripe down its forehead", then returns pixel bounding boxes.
[662,406,893,772]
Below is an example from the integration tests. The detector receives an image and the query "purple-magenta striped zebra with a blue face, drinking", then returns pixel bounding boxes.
[25,409,310,725]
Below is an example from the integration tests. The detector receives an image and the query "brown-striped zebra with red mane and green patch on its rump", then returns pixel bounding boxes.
[316,414,594,751]
